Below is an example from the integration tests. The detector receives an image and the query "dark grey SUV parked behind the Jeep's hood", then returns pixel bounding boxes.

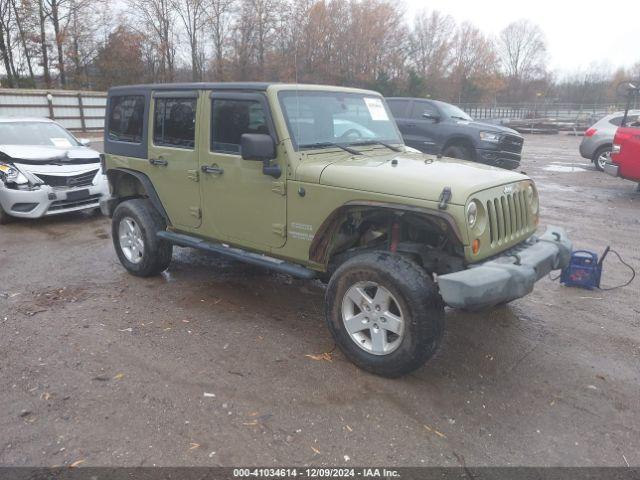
[387,98,524,170]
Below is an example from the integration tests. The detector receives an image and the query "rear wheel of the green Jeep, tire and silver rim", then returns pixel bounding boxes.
[111,198,173,277]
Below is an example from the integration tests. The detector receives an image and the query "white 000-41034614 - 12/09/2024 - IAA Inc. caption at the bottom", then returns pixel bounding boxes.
[233,468,400,478]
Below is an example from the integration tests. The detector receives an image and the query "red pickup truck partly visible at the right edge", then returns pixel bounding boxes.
[604,84,640,191]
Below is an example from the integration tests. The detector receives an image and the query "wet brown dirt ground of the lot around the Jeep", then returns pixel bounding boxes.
[0,135,640,466]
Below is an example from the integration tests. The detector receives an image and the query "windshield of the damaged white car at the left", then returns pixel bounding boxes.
[0,122,79,147]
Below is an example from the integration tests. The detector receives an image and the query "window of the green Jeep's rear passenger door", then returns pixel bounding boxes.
[153,98,196,148]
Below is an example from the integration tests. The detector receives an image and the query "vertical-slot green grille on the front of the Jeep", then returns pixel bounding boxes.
[486,190,530,246]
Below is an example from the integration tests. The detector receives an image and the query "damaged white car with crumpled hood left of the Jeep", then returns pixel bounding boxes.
[0,118,109,224]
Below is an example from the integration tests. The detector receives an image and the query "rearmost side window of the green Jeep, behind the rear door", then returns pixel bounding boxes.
[109,95,144,143]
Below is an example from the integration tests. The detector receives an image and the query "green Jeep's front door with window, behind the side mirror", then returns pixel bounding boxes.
[200,92,286,248]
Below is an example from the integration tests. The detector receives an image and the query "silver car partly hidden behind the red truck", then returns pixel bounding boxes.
[580,110,640,172]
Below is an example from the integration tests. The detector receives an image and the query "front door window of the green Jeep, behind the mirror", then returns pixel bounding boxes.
[211,99,269,154]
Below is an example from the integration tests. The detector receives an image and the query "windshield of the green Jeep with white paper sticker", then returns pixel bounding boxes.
[279,91,402,148]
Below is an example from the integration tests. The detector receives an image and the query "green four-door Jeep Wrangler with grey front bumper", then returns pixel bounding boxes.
[101,83,571,377]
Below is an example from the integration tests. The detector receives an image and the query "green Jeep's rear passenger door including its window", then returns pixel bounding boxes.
[148,91,201,230]
